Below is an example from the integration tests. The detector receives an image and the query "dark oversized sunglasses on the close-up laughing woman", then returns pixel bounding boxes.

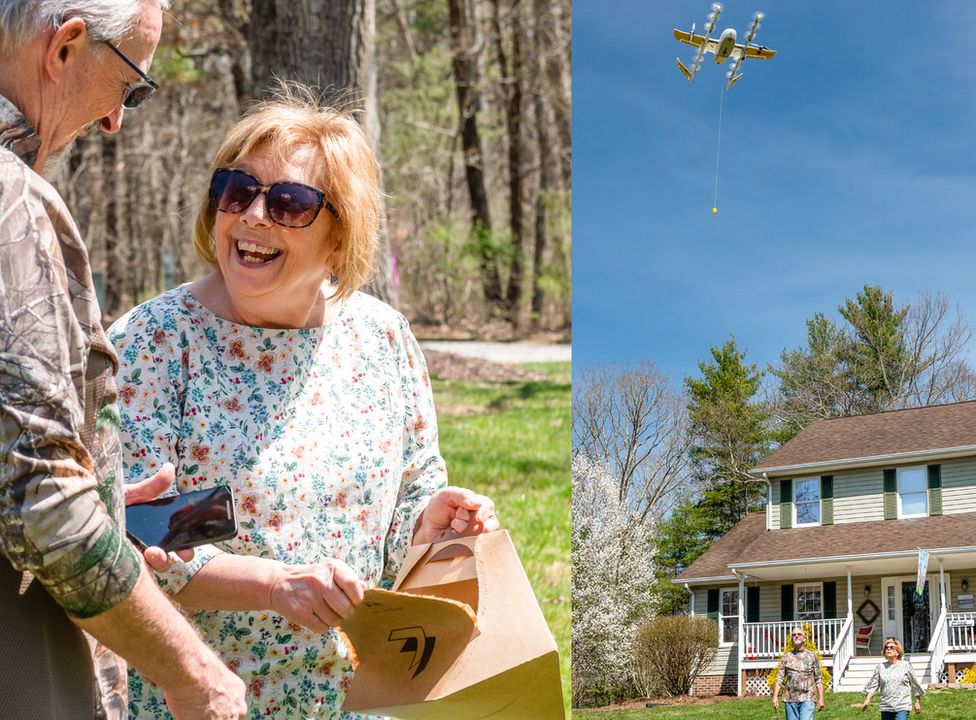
[210,168,339,228]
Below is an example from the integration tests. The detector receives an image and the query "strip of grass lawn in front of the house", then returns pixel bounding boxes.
[573,690,976,720]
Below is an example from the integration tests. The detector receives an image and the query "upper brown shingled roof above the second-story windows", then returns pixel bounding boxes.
[753,401,976,473]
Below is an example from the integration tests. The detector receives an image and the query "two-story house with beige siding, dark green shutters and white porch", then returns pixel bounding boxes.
[674,402,976,695]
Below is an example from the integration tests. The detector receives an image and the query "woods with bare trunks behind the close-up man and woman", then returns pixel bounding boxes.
[54,0,572,334]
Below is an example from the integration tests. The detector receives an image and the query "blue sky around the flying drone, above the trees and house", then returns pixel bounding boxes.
[573,0,976,386]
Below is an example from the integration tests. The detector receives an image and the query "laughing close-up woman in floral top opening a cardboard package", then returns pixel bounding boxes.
[111,87,498,719]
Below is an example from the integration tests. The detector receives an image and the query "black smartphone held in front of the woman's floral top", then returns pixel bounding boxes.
[125,486,237,551]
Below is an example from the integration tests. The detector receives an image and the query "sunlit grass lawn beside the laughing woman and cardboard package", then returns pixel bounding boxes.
[433,362,571,720]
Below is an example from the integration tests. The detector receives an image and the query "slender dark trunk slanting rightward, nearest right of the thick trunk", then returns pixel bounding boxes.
[448,0,502,305]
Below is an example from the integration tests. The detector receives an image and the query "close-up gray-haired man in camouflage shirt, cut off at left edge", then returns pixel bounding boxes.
[0,0,246,720]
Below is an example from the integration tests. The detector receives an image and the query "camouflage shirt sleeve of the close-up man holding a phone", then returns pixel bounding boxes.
[0,158,141,617]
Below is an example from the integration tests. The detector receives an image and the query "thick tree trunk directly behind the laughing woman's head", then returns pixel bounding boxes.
[248,0,397,305]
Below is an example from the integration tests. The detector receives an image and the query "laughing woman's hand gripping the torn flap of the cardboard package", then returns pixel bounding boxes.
[270,560,366,632]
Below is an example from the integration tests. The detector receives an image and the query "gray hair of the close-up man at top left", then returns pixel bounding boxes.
[0,0,170,52]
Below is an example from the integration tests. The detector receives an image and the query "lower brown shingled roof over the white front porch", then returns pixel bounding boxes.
[676,512,976,581]
